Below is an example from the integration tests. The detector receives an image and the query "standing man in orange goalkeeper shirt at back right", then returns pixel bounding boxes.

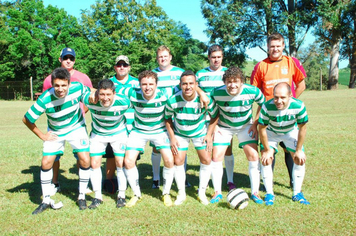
[251,33,306,186]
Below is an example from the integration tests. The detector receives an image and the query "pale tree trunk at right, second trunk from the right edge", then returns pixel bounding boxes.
[328,29,341,90]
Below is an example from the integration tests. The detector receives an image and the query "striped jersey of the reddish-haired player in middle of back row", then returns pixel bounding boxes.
[152,66,184,88]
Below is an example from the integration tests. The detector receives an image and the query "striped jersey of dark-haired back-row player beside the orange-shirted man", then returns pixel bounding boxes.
[196,66,227,93]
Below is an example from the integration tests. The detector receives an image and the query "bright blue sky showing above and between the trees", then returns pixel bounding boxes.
[43,0,348,68]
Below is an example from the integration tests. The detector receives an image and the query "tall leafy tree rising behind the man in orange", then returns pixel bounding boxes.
[202,0,315,65]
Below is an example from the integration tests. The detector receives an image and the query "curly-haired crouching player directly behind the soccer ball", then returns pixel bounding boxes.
[210,67,265,204]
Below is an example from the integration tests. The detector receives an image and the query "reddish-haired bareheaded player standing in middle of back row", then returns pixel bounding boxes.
[151,45,190,189]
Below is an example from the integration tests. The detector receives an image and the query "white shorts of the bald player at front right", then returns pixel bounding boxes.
[261,126,304,153]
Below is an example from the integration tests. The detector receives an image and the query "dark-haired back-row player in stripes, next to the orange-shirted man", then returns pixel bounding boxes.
[197,44,236,190]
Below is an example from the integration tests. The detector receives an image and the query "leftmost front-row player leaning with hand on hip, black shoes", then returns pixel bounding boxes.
[22,68,90,214]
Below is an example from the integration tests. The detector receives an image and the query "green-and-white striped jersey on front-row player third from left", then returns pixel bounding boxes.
[119,88,173,134]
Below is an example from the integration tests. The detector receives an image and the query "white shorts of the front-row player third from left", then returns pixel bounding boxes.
[126,130,171,152]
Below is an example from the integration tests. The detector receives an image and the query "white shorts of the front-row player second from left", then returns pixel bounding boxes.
[90,132,127,157]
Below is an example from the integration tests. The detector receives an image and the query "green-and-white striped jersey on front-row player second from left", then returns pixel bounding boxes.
[84,93,131,136]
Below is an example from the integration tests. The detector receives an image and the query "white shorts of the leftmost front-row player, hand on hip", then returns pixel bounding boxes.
[43,127,89,156]
